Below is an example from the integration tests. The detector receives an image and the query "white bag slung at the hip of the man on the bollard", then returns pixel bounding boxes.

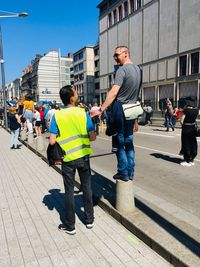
[122,101,144,120]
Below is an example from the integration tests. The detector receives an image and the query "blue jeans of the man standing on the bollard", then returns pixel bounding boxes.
[116,120,135,178]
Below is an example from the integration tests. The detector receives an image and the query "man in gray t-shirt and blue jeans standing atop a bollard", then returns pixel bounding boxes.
[91,46,142,181]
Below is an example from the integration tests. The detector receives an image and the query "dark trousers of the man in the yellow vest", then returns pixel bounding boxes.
[62,157,94,229]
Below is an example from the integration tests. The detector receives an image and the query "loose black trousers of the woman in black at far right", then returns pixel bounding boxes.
[181,125,197,162]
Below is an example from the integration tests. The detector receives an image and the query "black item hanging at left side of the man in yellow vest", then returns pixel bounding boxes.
[47,142,65,166]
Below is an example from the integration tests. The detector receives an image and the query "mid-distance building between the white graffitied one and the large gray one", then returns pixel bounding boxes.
[73,46,99,103]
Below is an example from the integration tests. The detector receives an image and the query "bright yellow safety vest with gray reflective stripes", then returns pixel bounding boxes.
[55,107,92,162]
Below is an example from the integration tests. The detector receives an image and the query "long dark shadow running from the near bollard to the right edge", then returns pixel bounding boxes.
[135,198,200,257]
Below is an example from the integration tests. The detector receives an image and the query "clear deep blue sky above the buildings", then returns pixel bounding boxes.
[0,0,101,83]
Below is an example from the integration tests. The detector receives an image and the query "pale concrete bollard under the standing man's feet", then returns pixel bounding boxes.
[116,180,135,213]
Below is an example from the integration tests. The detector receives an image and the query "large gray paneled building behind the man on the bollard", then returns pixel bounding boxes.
[98,0,200,110]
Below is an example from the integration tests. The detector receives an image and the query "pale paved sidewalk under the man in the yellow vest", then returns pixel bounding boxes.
[0,128,170,267]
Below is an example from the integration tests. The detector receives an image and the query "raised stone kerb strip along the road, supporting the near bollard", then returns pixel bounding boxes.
[7,129,200,267]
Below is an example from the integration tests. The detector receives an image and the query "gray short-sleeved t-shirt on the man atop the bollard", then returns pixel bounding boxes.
[114,64,141,104]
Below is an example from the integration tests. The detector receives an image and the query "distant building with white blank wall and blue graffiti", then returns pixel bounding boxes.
[21,50,73,102]
